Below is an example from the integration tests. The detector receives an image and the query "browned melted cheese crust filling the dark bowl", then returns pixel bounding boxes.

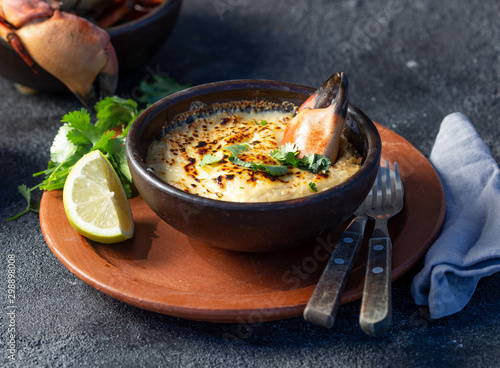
[146,104,362,202]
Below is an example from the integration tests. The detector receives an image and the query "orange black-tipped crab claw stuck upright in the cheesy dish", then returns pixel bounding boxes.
[281,73,349,162]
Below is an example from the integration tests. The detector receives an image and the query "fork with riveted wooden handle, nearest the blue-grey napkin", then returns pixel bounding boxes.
[359,161,404,336]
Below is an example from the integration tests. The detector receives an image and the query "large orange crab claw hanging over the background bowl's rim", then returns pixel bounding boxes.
[16,9,118,109]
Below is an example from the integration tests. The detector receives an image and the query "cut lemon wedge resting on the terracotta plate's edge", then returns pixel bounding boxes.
[63,150,134,243]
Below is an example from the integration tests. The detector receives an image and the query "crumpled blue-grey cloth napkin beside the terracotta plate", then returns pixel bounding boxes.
[411,113,500,318]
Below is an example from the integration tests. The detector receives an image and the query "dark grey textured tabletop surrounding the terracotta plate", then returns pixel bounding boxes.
[0,0,500,367]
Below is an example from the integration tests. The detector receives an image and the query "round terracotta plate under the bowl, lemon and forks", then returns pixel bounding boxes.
[40,125,445,323]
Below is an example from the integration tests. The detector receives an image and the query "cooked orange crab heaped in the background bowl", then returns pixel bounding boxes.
[0,0,162,108]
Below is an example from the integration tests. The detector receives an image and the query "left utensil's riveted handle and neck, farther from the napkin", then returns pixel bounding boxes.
[304,187,368,328]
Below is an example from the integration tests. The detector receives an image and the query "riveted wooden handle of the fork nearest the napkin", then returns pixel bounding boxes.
[359,237,392,336]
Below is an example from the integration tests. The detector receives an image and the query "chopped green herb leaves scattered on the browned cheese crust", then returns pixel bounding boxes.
[200,143,332,176]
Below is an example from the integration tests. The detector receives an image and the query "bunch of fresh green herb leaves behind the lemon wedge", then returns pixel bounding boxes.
[7,96,141,221]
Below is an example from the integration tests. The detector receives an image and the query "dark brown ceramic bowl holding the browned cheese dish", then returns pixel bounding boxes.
[126,80,381,252]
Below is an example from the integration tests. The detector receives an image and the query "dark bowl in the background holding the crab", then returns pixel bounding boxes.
[0,0,182,92]
